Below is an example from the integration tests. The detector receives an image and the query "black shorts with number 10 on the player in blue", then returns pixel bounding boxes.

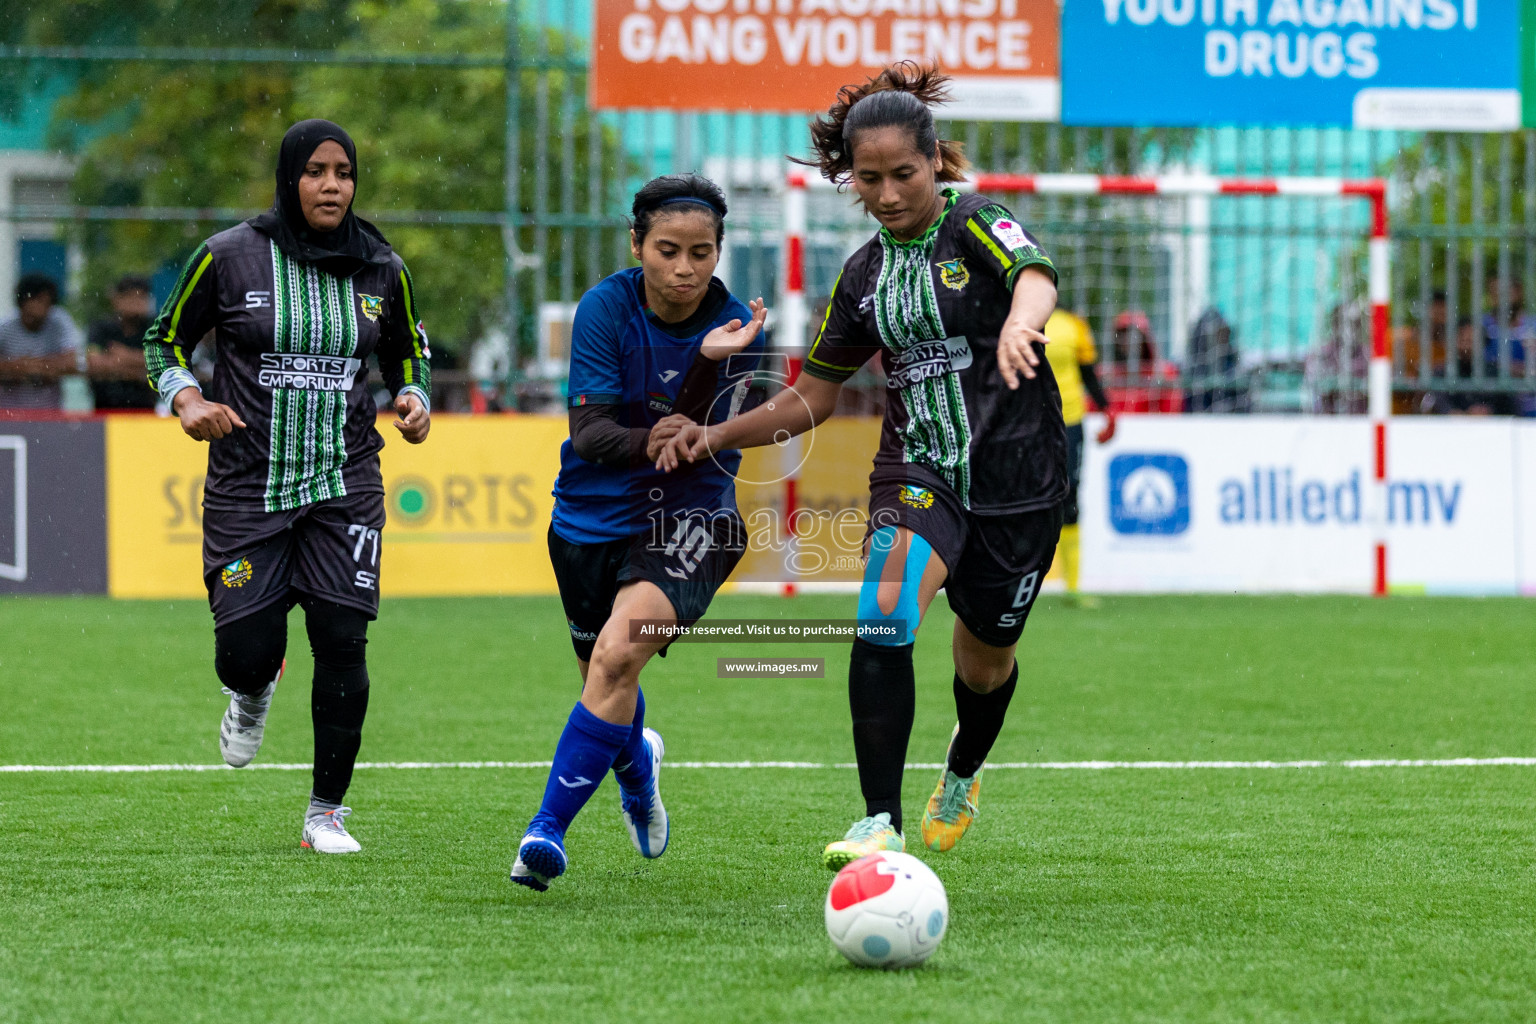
[550,511,746,662]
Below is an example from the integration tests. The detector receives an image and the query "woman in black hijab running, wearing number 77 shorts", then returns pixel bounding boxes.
[144,120,432,854]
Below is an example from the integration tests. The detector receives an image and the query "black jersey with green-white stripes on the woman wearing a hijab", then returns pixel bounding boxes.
[144,224,432,511]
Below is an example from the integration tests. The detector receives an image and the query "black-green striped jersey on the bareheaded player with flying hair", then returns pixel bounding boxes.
[805,189,1068,514]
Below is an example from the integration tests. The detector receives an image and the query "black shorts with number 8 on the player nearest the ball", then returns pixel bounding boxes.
[869,482,1061,648]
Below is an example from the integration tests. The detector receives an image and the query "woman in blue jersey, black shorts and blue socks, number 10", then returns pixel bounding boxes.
[511,175,766,890]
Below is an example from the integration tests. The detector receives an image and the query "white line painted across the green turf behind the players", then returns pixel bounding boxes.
[0,757,1536,774]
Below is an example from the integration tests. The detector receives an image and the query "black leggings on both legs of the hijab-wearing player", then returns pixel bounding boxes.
[214,594,369,803]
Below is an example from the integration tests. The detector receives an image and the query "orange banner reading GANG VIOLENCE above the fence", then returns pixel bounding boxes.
[591,0,1061,121]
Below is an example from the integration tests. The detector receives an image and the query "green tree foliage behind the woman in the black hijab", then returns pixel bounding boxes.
[31,0,621,360]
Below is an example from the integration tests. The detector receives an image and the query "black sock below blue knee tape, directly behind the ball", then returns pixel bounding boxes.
[848,640,917,832]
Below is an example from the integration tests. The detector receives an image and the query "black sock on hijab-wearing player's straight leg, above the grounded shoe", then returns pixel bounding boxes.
[303,597,369,804]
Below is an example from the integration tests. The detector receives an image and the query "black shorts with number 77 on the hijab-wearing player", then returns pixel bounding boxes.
[203,493,384,626]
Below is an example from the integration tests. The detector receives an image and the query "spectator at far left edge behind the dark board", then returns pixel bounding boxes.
[0,273,86,410]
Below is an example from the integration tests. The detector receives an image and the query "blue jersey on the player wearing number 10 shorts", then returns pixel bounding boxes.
[554,267,763,543]
